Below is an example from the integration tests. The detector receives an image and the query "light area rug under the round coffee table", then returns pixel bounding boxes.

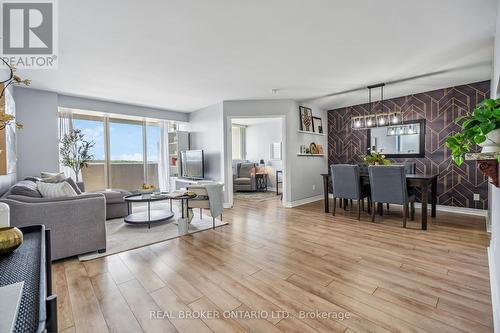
[78,201,228,261]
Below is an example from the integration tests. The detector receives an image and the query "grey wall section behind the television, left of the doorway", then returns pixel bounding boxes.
[189,103,224,181]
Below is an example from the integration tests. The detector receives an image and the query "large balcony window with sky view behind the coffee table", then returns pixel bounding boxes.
[65,109,177,191]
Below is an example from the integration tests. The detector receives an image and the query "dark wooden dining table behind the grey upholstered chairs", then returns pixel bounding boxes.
[321,173,439,230]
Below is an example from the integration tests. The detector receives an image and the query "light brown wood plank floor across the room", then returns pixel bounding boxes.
[53,196,493,333]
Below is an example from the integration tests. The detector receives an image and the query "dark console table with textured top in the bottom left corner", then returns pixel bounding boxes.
[0,225,57,332]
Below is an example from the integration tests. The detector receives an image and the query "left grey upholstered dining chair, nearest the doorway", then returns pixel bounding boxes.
[330,164,370,221]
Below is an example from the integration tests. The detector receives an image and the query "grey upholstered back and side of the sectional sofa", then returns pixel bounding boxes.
[0,181,106,260]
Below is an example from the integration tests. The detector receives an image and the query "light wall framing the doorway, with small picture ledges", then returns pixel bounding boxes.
[223,100,328,207]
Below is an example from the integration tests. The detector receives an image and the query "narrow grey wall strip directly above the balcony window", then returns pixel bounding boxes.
[58,95,189,121]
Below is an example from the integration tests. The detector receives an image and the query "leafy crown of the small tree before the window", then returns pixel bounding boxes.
[59,130,95,182]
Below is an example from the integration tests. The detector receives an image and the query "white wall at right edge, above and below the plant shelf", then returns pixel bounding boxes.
[488,0,500,332]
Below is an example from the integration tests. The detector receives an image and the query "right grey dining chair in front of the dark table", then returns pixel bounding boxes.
[368,165,415,228]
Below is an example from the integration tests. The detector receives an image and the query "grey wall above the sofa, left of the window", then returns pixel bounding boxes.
[14,87,59,179]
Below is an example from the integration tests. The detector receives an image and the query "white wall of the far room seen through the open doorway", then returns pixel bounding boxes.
[243,118,283,188]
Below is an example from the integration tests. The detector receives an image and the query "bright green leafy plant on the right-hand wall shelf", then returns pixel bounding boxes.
[446,98,500,166]
